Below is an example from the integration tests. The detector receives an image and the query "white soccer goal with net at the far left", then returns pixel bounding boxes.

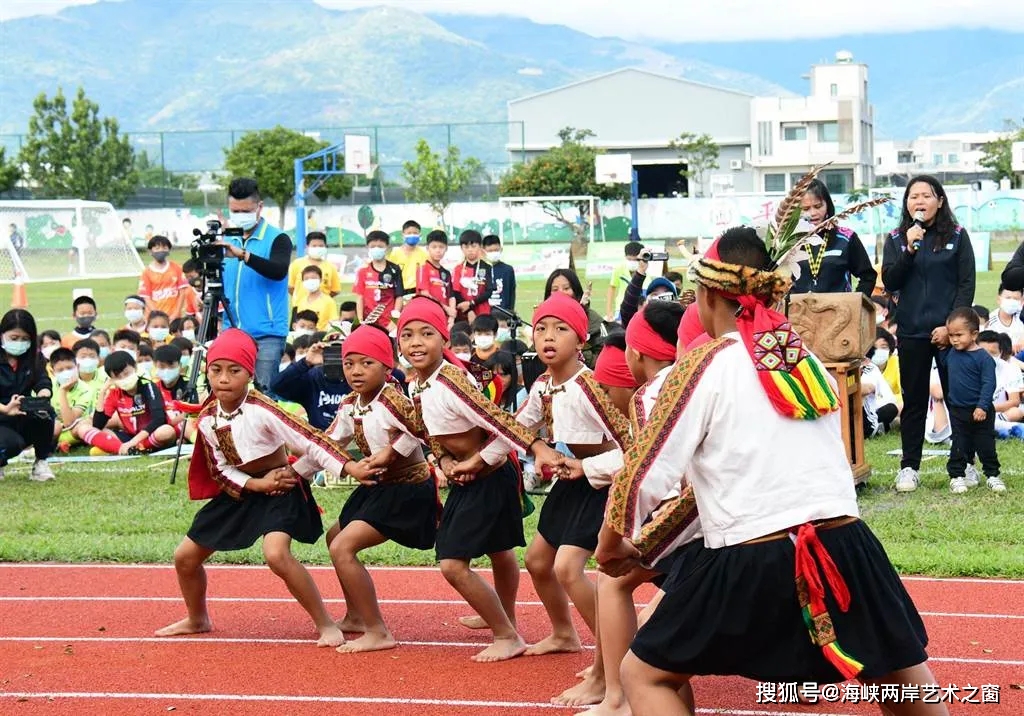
[0,200,143,284]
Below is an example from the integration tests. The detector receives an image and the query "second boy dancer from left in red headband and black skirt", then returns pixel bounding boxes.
[319,325,438,654]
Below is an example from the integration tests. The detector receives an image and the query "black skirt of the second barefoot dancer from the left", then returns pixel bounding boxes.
[338,476,440,549]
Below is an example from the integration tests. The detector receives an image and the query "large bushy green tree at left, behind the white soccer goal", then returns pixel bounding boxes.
[19,87,138,205]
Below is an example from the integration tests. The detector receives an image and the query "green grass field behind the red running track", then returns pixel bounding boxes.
[0,250,1024,578]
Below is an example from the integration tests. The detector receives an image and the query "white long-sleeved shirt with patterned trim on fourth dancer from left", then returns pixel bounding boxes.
[516,367,629,489]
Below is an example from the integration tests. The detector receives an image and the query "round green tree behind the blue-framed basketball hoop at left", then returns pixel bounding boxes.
[224,125,352,223]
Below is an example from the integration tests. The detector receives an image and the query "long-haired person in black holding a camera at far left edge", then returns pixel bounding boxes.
[0,308,55,482]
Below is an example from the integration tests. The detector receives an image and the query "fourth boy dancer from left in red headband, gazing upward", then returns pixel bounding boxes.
[516,293,630,706]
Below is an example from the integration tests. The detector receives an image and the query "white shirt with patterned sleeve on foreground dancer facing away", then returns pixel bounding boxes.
[609,333,859,548]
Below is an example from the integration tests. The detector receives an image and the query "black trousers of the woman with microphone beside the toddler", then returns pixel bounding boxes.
[899,338,949,470]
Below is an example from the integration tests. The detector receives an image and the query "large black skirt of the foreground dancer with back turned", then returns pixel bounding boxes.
[631,520,928,683]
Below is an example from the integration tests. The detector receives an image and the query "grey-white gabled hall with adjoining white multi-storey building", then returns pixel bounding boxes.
[507,52,873,198]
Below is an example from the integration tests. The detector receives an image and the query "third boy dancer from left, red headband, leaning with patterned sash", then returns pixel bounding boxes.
[398,296,558,662]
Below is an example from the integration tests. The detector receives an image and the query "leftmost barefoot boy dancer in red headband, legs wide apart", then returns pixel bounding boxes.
[157,328,348,646]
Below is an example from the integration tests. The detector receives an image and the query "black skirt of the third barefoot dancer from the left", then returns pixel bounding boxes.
[435,461,526,559]
